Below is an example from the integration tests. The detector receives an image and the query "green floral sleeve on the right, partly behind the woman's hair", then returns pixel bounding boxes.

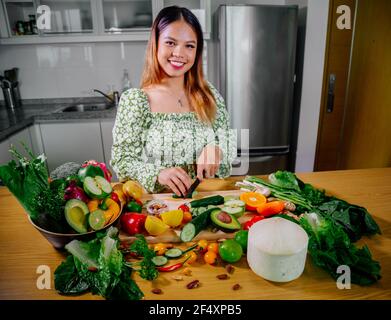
[208,82,237,178]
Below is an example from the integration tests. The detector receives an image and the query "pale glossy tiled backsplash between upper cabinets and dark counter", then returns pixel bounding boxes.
[0,42,147,100]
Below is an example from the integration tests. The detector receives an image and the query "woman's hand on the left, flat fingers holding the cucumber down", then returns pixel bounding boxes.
[157,167,192,196]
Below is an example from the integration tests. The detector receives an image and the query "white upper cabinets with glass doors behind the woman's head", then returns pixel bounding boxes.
[0,0,210,44]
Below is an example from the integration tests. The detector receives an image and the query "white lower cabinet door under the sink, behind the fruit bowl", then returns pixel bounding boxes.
[40,121,104,172]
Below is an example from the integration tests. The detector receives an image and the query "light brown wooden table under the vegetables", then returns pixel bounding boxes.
[0,168,391,300]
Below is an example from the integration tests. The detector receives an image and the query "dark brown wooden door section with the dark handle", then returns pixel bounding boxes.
[314,0,356,171]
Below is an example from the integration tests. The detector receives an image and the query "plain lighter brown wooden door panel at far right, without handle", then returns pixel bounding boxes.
[338,0,391,169]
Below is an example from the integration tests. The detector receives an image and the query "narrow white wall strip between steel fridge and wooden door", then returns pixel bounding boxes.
[286,0,329,172]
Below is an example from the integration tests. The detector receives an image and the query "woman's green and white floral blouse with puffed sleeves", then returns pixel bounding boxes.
[110,84,236,192]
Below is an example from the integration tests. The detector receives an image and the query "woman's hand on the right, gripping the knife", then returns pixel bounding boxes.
[197,145,222,181]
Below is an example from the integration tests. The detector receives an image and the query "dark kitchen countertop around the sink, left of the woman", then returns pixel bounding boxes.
[0,98,117,142]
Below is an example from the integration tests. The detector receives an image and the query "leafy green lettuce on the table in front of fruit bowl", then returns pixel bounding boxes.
[54,227,143,300]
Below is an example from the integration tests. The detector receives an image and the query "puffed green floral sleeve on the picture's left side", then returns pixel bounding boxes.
[110,88,163,192]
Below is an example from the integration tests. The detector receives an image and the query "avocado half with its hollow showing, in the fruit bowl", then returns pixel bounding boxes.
[65,199,89,233]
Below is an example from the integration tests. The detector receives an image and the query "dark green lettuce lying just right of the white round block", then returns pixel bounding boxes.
[299,213,381,285]
